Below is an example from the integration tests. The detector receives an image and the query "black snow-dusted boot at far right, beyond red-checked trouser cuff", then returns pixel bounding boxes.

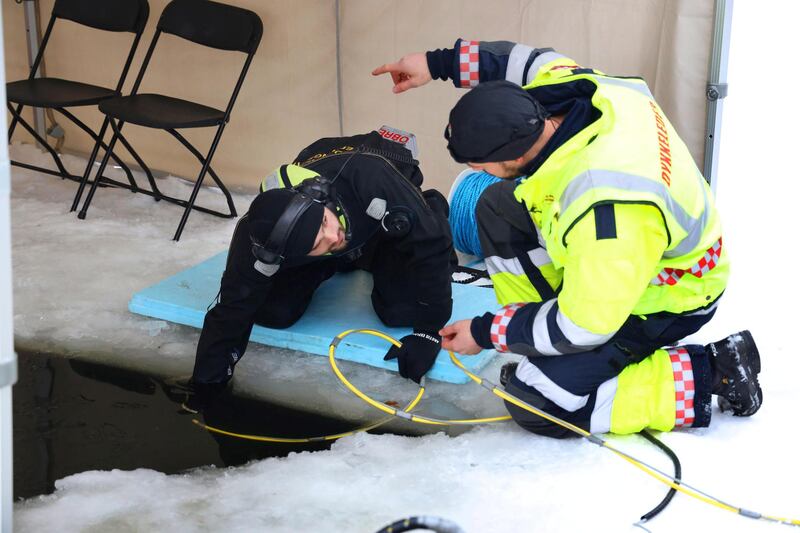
[706,330,763,416]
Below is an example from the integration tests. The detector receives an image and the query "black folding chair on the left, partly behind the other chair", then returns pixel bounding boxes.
[6,0,150,192]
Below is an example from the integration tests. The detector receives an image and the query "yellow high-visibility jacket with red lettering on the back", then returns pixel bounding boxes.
[484,52,729,355]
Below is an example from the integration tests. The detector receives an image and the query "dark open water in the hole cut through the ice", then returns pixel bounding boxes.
[13,353,352,499]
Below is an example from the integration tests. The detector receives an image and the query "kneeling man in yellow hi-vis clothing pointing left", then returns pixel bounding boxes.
[373,39,762,437]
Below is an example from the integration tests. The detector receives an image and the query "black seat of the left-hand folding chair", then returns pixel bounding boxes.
[6,78,118,108]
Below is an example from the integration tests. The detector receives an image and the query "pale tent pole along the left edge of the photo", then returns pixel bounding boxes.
[0,5,17,533]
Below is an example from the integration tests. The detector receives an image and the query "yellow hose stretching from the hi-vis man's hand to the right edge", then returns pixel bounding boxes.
[450,352,800,526]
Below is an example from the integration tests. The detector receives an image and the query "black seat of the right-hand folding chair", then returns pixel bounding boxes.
[100,94,225,130]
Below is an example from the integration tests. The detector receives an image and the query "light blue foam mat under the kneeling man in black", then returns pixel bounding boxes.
[128,252,499,383]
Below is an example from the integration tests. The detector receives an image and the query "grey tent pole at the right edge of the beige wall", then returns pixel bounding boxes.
[703,0,733,191]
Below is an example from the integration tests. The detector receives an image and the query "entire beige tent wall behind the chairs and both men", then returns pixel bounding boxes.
[3,0,714,192]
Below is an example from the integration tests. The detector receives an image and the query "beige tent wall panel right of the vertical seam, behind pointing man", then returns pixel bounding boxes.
[340,0,714,192]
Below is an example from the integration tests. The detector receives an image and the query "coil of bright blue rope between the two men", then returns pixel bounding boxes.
[450,171,500,257]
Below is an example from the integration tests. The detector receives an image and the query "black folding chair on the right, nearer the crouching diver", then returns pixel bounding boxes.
[76,0,263,241]
